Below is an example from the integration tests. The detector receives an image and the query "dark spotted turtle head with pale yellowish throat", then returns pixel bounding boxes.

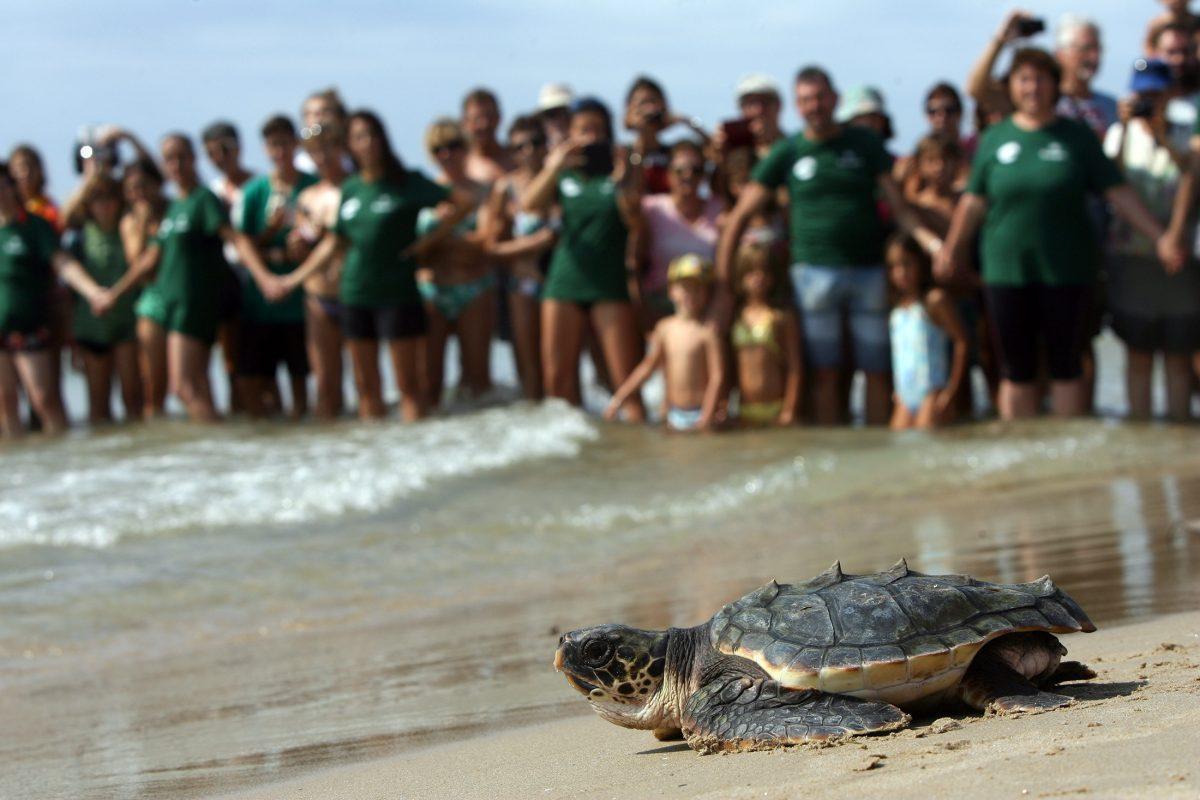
[554,625,668,729]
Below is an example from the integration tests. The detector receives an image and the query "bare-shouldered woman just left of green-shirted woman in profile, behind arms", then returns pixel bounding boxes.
[121,158,169,420]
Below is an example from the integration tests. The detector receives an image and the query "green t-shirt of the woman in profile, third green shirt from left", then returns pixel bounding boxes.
[155,186,229,315]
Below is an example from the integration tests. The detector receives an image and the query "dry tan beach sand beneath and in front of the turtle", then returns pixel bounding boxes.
[223,612,1200,800]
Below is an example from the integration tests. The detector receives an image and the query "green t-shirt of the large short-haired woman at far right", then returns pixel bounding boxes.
[967,118,1122,287]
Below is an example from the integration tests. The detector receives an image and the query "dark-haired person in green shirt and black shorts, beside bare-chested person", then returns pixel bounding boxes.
[238,116,317,417]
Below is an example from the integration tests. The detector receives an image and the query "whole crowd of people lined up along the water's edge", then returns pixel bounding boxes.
[0,0,1200,437]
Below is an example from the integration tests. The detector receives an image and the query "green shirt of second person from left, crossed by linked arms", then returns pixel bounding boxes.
[68,222,138,344]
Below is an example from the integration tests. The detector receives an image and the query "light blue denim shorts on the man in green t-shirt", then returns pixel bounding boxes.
[792,264,892,373]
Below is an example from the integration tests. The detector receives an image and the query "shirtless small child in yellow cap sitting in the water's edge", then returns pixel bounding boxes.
[605,253,725,431]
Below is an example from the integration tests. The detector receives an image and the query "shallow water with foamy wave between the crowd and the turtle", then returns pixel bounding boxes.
[0,340,1200,798]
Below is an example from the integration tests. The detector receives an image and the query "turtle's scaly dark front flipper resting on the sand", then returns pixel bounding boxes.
[683,675,911,753]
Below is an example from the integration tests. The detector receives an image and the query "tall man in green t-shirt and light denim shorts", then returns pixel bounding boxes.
[716,67,941,425]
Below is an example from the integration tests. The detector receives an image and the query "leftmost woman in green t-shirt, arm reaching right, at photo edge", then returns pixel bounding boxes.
[0,163,102,437]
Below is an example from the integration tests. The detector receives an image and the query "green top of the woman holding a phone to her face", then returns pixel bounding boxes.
[542,170,629,302]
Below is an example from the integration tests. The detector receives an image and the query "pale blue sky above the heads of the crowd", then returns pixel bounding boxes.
[0,0,1162,195]
